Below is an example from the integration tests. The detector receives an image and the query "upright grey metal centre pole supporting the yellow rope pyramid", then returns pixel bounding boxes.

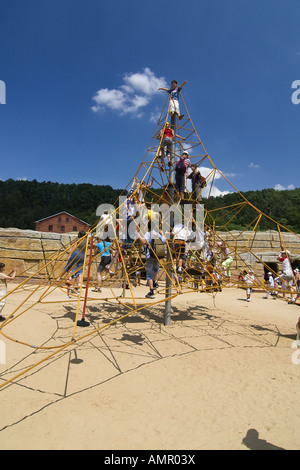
[164,116,176,326]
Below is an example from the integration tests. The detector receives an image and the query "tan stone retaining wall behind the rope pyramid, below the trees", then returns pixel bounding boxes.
[0,228,300,278]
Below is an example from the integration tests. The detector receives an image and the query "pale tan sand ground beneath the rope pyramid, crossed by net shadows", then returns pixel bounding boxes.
[0,284,300,451]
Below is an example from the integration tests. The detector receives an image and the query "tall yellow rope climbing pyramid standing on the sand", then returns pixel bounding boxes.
[0,89,300,388]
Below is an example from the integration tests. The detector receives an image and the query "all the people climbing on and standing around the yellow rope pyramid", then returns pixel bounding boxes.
[0,80,300,310]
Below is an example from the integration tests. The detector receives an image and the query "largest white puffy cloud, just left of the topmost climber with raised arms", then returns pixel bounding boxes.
[91,67,167,119]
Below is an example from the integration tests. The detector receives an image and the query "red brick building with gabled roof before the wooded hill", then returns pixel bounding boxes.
[35,212,90,233]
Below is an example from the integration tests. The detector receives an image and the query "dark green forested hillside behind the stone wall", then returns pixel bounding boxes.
[0,179,300,233]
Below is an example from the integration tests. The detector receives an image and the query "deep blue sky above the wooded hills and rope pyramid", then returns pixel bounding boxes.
[0,0,300,195]
